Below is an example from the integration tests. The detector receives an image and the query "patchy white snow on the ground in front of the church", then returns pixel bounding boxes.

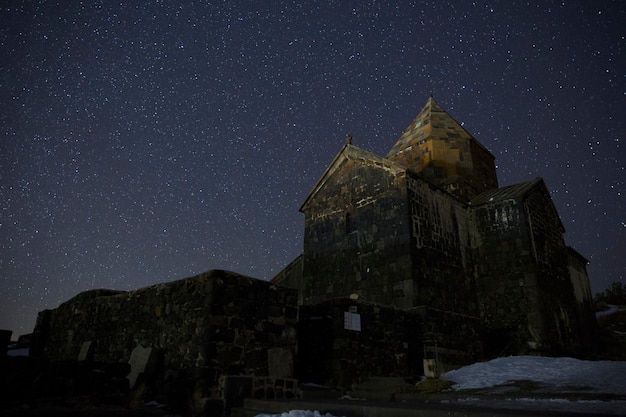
[252,356,626,417]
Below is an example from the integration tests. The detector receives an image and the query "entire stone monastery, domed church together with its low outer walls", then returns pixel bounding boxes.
[31,97,597,415]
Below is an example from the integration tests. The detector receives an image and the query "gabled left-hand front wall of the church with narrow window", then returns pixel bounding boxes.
[302,147,411,307]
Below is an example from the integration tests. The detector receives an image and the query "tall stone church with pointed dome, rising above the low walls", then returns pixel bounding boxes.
[273,96,595,356]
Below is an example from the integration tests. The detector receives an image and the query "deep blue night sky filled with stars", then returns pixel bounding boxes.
[0,0,626,337]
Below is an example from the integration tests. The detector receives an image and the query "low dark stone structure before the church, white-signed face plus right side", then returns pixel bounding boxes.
[296,299,482,389]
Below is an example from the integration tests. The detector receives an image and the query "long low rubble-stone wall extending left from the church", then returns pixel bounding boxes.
[33,271,298,410]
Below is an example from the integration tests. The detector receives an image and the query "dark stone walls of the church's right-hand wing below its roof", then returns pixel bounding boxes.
[469,182,582,356]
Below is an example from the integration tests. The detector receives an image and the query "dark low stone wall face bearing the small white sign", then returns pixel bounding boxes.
[296,299,422,389]
